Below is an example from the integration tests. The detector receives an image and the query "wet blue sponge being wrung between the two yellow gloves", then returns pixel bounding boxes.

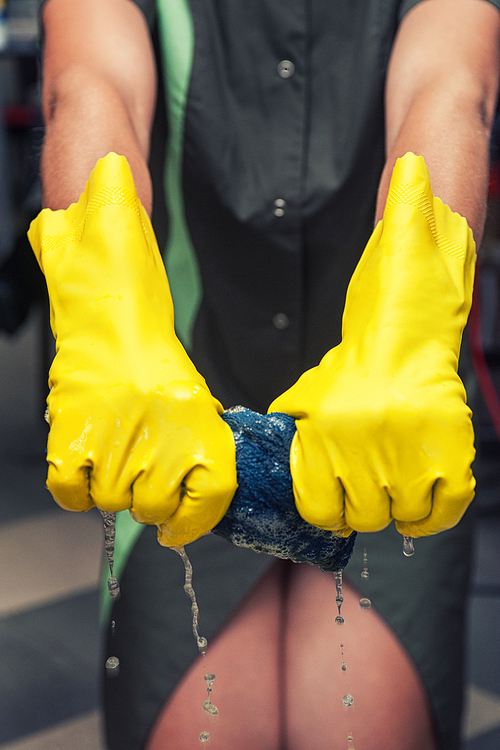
[213,406,356,571]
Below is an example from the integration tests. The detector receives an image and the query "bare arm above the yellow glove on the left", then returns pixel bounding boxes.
[42,0,156,212]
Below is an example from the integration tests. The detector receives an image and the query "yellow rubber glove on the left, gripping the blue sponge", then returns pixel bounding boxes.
[29,153,236,547]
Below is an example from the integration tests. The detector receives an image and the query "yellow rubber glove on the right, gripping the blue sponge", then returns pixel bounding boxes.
[270,153,475,536]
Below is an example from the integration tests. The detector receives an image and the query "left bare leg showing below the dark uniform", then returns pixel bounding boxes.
[146,562,285,750]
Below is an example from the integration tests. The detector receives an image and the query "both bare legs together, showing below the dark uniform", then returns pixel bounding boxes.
[147,562,436,750]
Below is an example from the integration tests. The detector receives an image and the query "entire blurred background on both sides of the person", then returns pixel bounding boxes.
[0,0,500,750]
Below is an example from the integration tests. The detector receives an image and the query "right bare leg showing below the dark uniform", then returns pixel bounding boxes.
[285,565,437,750]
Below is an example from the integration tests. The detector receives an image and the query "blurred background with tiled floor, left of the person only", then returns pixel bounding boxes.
[0,0,104,750]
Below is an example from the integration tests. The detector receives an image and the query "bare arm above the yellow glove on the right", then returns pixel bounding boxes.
[377,0,500,244]
